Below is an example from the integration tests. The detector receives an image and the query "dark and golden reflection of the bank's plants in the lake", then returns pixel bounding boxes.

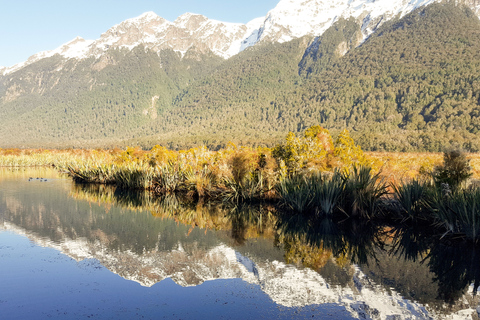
[73,185,480,312]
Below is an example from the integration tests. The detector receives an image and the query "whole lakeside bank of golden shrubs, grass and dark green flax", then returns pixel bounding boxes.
[0,126,480,241]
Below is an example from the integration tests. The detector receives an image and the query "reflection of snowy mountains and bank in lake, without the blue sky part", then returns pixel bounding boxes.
[0,172,480,319]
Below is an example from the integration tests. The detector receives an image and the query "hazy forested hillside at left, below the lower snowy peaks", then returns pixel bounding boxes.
[0,47,223,147]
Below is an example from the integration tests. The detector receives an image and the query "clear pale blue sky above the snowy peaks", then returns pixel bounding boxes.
[0,0,280,67]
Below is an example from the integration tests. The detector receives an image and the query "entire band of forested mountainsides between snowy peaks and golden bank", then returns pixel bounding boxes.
[0,3,480,151]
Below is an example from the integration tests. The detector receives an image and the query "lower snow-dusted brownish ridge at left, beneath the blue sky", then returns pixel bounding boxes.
[0,12,262,74]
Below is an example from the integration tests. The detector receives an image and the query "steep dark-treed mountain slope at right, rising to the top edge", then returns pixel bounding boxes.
[304,4,480,151]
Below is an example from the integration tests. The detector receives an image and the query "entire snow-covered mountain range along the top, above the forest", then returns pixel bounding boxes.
[0,0,480,74]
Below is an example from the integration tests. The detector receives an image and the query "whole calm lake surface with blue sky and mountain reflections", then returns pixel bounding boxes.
[0,170,480,319]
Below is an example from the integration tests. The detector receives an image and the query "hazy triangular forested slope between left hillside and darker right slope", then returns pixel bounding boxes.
[137,38,309,148]
